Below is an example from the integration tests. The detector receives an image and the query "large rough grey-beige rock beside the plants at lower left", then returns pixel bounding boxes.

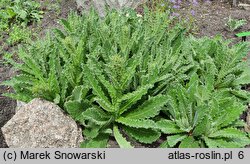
[2,99,83,148]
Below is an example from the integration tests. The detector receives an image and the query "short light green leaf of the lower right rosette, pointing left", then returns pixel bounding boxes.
[156,120,185,134]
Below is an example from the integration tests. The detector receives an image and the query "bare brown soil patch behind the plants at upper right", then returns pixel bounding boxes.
[188,0,250,42]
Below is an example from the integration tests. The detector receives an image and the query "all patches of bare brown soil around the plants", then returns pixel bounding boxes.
[0,0,250,148]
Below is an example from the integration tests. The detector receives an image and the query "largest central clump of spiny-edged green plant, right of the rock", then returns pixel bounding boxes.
[66,8,192,148]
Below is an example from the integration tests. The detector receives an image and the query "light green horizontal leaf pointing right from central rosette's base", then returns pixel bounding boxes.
[115,117,157,129]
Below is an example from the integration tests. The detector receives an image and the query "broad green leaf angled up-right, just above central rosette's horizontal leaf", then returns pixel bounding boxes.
[125,95,168,119]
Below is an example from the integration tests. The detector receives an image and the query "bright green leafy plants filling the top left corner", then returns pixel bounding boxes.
[0,0,43,55]
